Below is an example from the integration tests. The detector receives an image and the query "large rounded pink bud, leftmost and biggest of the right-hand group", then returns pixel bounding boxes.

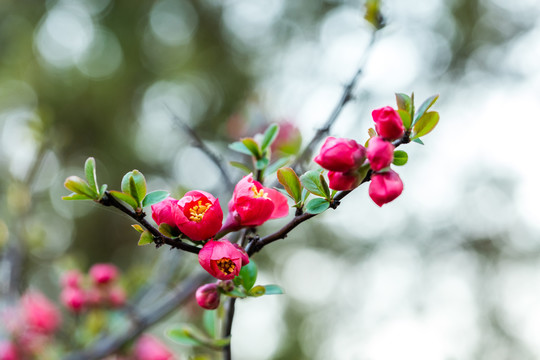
[314,136,366,171]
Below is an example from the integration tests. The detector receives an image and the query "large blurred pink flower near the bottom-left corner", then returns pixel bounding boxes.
[21,291,61,334]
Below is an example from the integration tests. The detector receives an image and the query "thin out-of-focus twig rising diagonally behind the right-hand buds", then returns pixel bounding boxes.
[291,30,377,172]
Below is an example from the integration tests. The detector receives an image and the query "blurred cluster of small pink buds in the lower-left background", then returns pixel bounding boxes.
[60,264,126,313]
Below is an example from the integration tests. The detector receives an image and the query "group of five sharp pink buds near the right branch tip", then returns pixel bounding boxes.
[314,106,405,206]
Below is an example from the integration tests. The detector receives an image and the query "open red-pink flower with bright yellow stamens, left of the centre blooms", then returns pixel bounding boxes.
[176,190,223,241]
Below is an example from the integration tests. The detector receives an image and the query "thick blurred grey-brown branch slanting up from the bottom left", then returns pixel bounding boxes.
[64,272,211,360]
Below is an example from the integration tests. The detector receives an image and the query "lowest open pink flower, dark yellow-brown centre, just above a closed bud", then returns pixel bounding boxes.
[199,239,249,280]
